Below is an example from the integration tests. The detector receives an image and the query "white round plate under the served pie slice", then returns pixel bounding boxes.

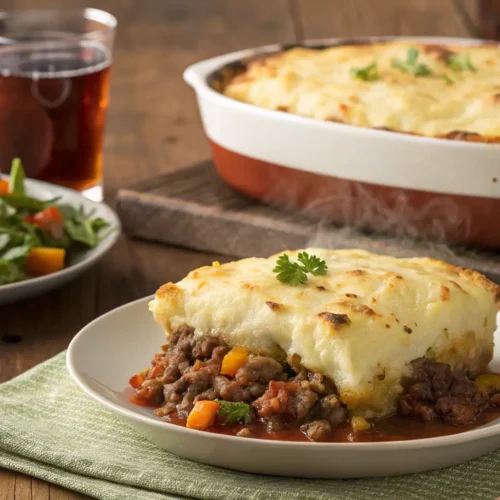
[67,297,500,478]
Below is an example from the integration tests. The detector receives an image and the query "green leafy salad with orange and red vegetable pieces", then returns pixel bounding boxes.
[0,158,113,285]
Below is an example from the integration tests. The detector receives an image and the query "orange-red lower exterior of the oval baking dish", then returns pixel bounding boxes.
[209,140,500,248]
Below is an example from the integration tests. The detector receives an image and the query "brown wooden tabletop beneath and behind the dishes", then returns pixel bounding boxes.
[0,0,477,500]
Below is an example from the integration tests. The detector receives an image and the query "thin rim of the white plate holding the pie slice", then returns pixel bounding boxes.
[66,295,500,452]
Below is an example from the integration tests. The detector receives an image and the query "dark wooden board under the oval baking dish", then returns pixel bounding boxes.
[117,161,500,282]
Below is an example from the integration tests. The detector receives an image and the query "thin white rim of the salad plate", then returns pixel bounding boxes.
[0,174,122,293]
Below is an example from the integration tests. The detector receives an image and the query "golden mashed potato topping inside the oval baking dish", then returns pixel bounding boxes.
[223,41,500,142]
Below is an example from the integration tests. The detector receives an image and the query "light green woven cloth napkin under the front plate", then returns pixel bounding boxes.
[0,353,500,500]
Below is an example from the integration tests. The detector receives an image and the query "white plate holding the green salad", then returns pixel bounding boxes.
[0,176,121,304]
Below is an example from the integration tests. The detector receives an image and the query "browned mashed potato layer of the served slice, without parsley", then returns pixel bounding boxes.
[150,248,500,417]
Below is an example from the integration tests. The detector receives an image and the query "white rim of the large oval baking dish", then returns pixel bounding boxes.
[183,36,500,150]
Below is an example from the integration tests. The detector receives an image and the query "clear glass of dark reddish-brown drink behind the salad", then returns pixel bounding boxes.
[0,9,117,201]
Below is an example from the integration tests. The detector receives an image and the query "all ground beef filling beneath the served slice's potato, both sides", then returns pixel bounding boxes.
[136,326,500,441]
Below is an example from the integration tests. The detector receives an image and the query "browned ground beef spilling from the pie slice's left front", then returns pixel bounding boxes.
[136,327,346,440]
